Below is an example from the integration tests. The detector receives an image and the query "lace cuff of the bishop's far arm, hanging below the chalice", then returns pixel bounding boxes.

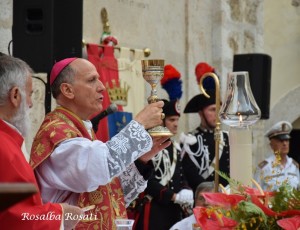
[119,163,147,207]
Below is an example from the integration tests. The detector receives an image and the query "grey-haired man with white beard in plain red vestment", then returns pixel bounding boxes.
[0,55,83,230]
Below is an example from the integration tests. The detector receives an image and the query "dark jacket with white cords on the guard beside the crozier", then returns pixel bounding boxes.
[181,127,230,191]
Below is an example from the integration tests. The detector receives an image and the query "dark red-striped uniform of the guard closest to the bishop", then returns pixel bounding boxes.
[136,140,188,230]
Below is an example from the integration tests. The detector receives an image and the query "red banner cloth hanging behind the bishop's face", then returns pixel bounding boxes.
[87,44,123,142]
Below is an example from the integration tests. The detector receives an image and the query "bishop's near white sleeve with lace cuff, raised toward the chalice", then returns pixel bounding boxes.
[36,118,152,193]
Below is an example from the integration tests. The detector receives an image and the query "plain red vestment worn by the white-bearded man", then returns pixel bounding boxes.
[0,120,62,230]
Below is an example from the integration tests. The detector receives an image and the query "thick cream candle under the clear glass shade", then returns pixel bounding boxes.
[229,127,252,185]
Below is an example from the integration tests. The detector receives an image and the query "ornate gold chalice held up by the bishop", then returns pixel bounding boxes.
[142,59,173,137]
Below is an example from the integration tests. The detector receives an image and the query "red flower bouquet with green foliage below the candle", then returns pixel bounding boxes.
[194,174,300,230]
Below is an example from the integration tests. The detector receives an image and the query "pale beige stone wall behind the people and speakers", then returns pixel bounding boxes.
[0,0,300,171]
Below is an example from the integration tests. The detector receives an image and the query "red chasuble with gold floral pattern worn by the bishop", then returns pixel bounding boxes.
[30,107,126,230]
